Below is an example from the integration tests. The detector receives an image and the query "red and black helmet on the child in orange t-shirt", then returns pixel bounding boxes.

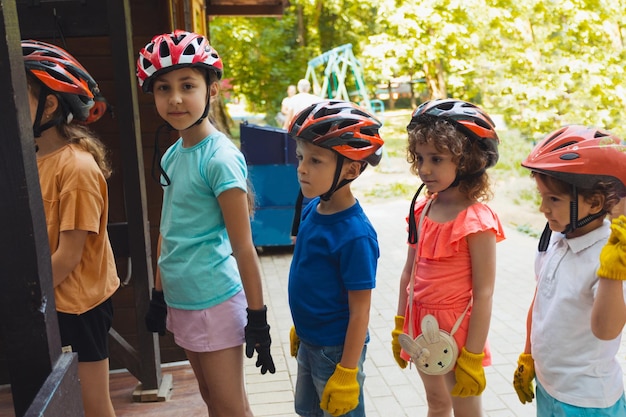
[22,40,100,122]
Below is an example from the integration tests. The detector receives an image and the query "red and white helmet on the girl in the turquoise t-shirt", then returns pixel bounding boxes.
[137,30,224,93]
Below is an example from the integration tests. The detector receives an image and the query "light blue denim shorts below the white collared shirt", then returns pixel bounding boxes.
[535,379,626,417]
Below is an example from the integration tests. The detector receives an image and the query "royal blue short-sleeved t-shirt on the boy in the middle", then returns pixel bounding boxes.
[289,198,379,346]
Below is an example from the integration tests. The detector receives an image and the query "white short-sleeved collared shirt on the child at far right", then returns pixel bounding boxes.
[531,220,626,408]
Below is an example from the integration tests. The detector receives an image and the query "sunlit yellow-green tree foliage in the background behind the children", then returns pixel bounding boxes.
[210,0,626,143]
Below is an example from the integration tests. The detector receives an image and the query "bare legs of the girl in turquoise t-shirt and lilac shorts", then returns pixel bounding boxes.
[185,346,252,417]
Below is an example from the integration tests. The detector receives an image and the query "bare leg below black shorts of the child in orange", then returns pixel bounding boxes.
[78,359,115,417]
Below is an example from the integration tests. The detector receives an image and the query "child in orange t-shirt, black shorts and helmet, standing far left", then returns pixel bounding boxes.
[22,40,120,417]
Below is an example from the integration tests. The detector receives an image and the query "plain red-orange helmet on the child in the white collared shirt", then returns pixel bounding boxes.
[522,125,626,197]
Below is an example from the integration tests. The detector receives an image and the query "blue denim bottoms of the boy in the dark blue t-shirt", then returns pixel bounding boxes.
[295,342,367,417]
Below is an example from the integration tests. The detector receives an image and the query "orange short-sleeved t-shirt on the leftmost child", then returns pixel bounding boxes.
[37,144,120,314]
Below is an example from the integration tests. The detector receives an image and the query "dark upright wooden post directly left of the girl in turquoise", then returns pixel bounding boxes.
[106,0,162,389]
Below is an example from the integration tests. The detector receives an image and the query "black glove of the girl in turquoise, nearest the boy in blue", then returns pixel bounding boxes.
[245,306,276,375]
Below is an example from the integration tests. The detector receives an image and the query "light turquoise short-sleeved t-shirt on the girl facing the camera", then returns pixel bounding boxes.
[159,132,247,310]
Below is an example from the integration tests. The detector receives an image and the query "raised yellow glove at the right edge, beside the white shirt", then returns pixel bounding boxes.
[598,215,626,281]
